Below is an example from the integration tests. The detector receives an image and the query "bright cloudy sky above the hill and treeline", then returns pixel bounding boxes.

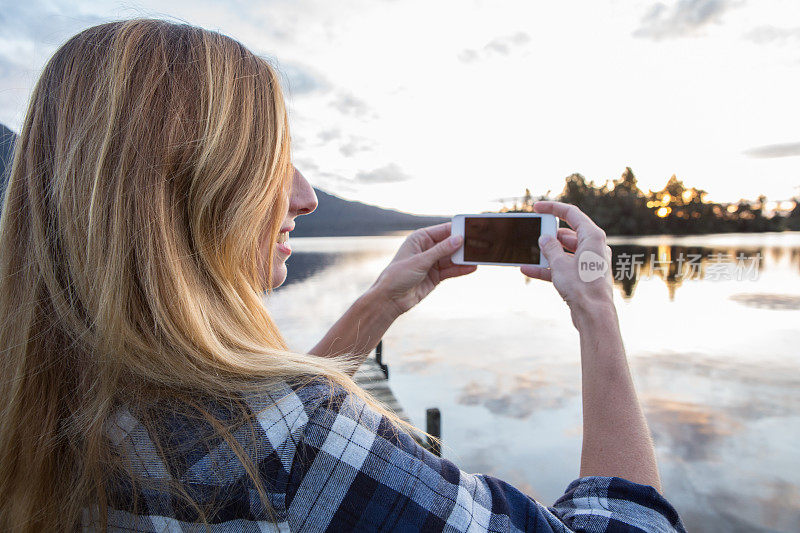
[0,0,800,215]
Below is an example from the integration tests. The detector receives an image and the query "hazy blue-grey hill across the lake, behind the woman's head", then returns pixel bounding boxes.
[0,124,450,237]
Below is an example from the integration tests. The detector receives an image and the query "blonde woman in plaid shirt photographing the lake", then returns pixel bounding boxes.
[0,19,683,531]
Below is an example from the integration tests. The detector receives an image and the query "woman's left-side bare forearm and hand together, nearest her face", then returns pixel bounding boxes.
[309,222,477,372]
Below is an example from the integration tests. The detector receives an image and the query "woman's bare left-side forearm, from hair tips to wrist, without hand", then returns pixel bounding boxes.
[308,289,397,372]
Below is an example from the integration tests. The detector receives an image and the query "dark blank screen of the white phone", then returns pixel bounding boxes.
[464,217,542,264]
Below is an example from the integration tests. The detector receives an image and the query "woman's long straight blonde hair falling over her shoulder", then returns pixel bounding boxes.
[0,19,438,531]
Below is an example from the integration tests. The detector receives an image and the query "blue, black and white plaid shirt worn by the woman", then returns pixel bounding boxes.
[92,376,685,532]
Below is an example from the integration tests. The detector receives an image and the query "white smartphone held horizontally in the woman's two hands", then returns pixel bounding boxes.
[450,213,558,267]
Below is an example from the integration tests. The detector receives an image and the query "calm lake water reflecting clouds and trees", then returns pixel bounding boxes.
[267,232,800,532]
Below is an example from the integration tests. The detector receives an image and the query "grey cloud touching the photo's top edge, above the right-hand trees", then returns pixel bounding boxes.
[633,0,741,41]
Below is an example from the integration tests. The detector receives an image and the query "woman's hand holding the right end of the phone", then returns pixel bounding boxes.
[520,201,614,326]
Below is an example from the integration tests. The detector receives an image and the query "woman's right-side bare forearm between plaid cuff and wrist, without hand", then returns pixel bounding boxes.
[573,303,661,491]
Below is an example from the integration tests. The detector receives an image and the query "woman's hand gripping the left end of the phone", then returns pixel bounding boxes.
[371,222,478,316]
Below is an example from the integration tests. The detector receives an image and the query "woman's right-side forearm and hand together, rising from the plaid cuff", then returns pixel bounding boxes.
[522,201,661,491]
